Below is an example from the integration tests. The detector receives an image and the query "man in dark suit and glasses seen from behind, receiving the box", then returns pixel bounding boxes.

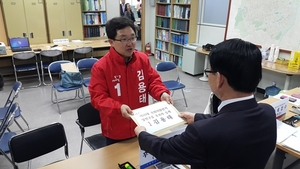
[135,39,276,169]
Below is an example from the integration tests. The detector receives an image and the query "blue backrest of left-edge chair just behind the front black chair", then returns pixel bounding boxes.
[0,103,19,140]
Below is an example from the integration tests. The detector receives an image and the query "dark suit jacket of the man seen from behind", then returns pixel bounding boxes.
[138,98,276,169]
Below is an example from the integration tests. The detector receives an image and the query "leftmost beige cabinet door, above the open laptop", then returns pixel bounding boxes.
[2,0,28,37]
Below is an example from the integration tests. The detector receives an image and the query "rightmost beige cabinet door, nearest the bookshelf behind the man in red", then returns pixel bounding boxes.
[64,0,83,40]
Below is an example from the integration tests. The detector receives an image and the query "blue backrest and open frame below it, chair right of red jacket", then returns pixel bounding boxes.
[156,61,180,82]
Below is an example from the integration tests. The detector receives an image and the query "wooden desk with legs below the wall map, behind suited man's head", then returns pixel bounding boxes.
[196,47,300,90]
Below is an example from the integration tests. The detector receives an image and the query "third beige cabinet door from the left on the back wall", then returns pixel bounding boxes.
[46,0,68,42]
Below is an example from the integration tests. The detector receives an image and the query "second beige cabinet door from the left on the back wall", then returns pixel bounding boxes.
[24,0,48,44]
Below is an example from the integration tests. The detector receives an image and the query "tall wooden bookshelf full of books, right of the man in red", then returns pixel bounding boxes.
[154,0,199,67]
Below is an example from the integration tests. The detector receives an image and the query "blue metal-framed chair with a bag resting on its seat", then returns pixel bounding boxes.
[48,60,86,114]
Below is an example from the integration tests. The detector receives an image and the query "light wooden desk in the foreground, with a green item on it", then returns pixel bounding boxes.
[41,138,139,169]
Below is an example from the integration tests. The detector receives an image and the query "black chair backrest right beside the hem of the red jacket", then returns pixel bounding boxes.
[77,103,101,127]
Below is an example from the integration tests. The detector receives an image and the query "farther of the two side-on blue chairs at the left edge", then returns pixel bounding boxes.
[0,81,29,131]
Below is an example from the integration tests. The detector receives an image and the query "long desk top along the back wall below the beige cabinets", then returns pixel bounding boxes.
[0,39,110,58]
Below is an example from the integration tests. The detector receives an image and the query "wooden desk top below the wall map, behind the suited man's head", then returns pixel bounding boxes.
[196,47,300,75]
